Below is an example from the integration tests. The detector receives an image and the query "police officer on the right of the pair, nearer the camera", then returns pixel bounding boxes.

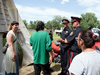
[62,17,82,75]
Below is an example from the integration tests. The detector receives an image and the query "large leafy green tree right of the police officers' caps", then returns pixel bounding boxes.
[80,13,100,29]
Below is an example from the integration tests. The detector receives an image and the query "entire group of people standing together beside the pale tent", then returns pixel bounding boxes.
[5,17,100,75]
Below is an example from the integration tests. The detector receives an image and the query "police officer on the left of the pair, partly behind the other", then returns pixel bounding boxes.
[57,19,71,75]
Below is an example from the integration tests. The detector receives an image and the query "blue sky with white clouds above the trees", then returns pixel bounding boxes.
[13,0,100,22]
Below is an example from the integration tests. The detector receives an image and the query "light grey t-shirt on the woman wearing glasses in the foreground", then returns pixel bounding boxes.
[69,50,100,75]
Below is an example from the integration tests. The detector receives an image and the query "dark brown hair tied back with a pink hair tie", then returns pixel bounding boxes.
[80,30,100,48]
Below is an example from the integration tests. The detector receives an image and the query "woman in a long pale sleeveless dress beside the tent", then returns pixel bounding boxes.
[5,21,20,75]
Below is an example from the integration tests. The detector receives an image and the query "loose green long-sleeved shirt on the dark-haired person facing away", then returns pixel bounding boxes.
[30,30,52,64]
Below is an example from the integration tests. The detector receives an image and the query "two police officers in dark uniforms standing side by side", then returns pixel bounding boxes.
[57,17,82,75]
